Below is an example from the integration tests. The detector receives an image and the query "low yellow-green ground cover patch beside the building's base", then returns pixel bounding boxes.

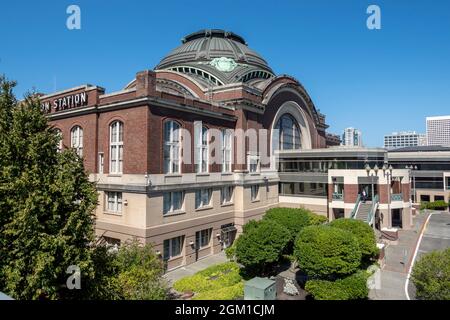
[173,262,244,300]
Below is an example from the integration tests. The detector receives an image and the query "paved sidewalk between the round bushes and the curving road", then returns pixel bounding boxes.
[369,213,428,300]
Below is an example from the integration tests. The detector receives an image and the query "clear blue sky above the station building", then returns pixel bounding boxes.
[0,0,450,146]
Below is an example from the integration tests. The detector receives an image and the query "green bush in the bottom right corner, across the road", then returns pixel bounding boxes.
[411,248,450,300]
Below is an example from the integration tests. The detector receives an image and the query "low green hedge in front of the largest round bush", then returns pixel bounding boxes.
[305,271,369,300]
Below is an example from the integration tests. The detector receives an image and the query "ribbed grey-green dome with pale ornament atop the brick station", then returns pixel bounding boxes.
[155,29,274,86]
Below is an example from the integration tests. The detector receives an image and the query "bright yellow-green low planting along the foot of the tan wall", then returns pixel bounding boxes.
[173,262,242,293]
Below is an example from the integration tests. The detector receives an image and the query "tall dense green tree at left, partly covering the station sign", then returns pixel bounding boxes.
[0,77,97,299]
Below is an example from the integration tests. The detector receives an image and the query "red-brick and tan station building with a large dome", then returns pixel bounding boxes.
[41,30,327,269]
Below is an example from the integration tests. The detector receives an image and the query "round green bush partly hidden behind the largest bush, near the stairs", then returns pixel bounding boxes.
[330,219,379,261]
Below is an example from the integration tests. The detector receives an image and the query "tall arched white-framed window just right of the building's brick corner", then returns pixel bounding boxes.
[164,121,181,173]
